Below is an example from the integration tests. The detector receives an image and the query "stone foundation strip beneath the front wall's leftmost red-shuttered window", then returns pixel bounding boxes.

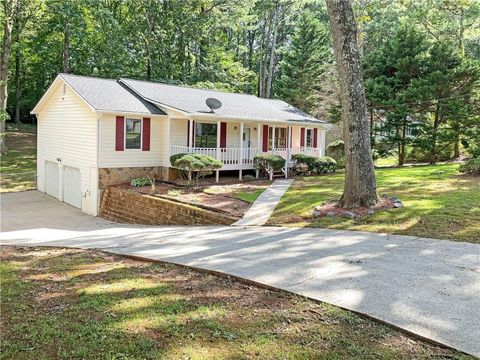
[98,166,176,190]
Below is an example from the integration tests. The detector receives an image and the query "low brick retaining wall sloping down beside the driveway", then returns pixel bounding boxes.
[100,187,238,225]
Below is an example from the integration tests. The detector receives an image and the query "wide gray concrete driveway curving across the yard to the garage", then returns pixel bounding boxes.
[0,191,480,356]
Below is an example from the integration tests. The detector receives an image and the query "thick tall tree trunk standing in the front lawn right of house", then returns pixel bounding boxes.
[327,0,378,209]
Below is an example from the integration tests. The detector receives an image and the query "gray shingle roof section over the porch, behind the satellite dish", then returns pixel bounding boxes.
[120,79,325,123]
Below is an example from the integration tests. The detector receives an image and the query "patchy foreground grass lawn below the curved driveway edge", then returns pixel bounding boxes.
[0,247,470,360]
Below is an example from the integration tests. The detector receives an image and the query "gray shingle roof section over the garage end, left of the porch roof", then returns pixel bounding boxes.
[59,74,165,115]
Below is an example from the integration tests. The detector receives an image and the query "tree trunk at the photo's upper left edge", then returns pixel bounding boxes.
[0,0,15,154]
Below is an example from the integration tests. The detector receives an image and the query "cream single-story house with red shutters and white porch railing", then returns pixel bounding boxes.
[32,74,329,215]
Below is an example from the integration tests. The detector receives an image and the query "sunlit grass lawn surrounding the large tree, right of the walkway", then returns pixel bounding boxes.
[269,164,480,243]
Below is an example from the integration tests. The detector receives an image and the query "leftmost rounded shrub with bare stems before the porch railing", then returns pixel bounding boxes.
[170,153,223,186]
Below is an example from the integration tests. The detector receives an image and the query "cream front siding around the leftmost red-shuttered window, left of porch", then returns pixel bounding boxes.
[99,114,168,168]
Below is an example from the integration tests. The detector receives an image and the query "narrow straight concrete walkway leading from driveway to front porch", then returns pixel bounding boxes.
[233,179,293,226]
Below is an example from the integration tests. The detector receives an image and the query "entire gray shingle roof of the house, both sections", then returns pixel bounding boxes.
[55,74,325,124]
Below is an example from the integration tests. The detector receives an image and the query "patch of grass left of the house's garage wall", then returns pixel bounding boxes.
[0,125,37,192]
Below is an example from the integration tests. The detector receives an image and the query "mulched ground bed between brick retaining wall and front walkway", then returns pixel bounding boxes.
[129,179,270,217]
